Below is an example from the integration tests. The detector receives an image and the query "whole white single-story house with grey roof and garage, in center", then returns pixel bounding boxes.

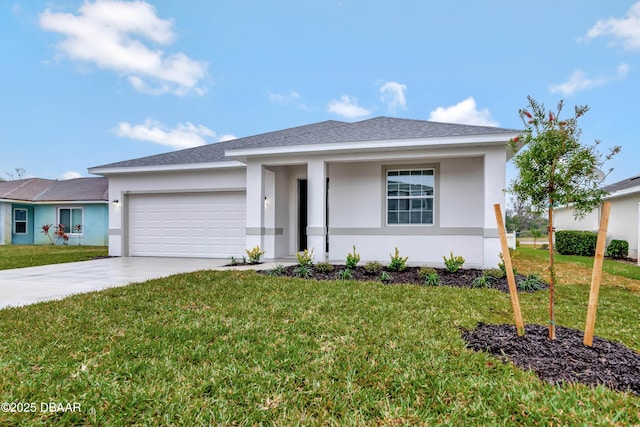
[89,117,521,267]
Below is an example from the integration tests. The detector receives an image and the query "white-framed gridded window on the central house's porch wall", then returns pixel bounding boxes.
[387,169,435,225]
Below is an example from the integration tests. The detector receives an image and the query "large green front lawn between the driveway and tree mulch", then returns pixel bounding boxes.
[0,271,640,426]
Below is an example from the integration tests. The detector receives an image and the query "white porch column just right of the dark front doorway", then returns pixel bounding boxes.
[307,160,327,262]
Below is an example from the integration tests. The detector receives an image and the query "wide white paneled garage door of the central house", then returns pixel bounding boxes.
[129,192,246,258]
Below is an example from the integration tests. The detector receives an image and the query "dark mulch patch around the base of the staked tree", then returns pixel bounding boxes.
[462,323,640,395]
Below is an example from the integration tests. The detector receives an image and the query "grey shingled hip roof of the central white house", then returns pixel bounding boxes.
[92,117,520,169]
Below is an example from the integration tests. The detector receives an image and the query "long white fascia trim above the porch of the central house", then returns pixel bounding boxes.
[225,132,521,159]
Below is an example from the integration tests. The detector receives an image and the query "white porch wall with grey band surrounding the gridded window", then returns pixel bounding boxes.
[329,157,492,267]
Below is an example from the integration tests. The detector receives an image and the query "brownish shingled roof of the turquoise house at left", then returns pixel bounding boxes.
[0,177,109,202]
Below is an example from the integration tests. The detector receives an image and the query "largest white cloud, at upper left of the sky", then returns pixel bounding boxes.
[40,0,207,95]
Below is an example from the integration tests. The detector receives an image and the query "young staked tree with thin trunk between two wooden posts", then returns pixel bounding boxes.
[509,96,620,339]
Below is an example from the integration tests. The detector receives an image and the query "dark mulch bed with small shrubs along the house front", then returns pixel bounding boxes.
[263,265,548,293]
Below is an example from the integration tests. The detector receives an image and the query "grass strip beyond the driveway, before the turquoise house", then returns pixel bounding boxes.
[0,245,108,270]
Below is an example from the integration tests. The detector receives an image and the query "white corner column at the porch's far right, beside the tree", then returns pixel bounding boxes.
[483,148,507,268]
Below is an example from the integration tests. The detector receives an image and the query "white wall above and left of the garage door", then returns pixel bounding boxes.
[109,168,245,256]
